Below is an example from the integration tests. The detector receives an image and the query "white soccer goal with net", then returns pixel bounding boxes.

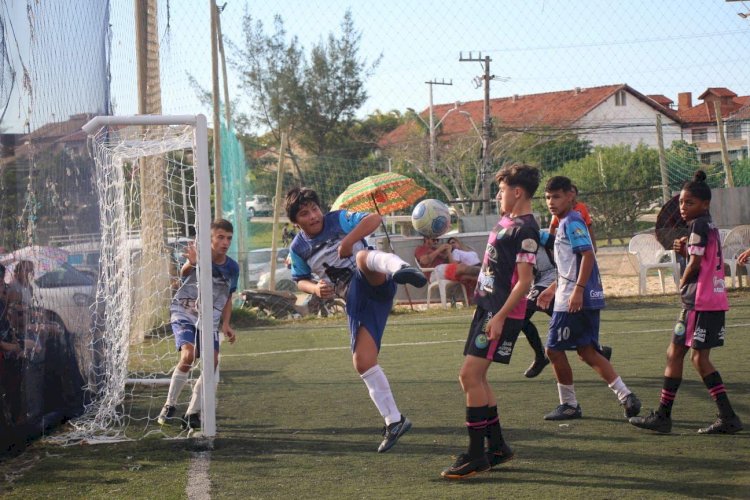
[58,115,216,442]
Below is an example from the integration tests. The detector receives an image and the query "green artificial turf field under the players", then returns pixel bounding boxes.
[0,291,750,499]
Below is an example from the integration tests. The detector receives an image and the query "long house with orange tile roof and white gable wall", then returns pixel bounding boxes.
[379,84,682,155]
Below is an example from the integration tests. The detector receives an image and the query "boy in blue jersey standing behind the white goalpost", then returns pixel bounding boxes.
[157,219,240,429]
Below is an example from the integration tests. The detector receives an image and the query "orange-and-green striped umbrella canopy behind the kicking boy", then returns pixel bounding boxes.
[331,172,427,214]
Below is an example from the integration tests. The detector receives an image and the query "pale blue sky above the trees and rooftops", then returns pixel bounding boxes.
[0,0,750,134]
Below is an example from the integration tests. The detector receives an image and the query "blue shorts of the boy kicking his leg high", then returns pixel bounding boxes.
[346,269,396,352]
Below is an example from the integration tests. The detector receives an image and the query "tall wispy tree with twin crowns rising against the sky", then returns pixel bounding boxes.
[230,11,380,177]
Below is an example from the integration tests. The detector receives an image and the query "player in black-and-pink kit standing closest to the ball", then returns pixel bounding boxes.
[441,165,539,479]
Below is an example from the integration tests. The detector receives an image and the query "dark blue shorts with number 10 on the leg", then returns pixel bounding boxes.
[547,309,599,351]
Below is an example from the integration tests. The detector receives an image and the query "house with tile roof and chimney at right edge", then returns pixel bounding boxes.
[677,87,750,164]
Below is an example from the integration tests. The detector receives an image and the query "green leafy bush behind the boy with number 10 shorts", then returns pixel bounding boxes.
[555,144,661,238]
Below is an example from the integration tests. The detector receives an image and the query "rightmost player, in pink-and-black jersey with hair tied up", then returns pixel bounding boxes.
[630,170,742,434]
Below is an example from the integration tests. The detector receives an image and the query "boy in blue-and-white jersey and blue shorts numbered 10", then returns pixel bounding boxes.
[537,176,641,420]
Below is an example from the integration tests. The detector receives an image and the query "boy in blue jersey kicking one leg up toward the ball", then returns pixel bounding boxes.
[285,188,427,453]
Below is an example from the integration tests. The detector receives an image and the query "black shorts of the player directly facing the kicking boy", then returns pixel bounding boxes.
[464,307,524,365]
